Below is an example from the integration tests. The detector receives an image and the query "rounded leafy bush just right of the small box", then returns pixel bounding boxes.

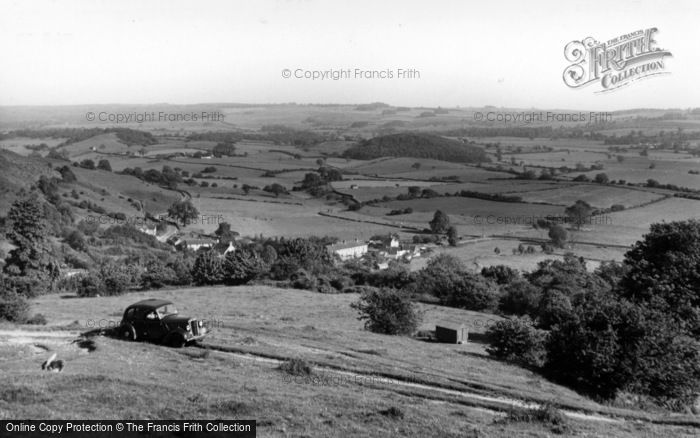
[486,316,546,367]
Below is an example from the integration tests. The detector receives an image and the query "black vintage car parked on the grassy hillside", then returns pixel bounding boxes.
[119,298,207,347]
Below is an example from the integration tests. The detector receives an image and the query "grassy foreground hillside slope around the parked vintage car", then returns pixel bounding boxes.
[0,287,696,437]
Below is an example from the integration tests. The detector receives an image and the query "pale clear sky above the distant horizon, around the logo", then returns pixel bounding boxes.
[0,0,700,111]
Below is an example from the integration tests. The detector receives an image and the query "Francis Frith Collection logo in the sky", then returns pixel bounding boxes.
[564,27,673,93]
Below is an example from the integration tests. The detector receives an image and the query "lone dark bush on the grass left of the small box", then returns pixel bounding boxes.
[351,289,421,335]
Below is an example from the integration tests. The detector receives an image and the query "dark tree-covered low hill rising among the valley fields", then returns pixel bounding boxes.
[343,133,489,163]
